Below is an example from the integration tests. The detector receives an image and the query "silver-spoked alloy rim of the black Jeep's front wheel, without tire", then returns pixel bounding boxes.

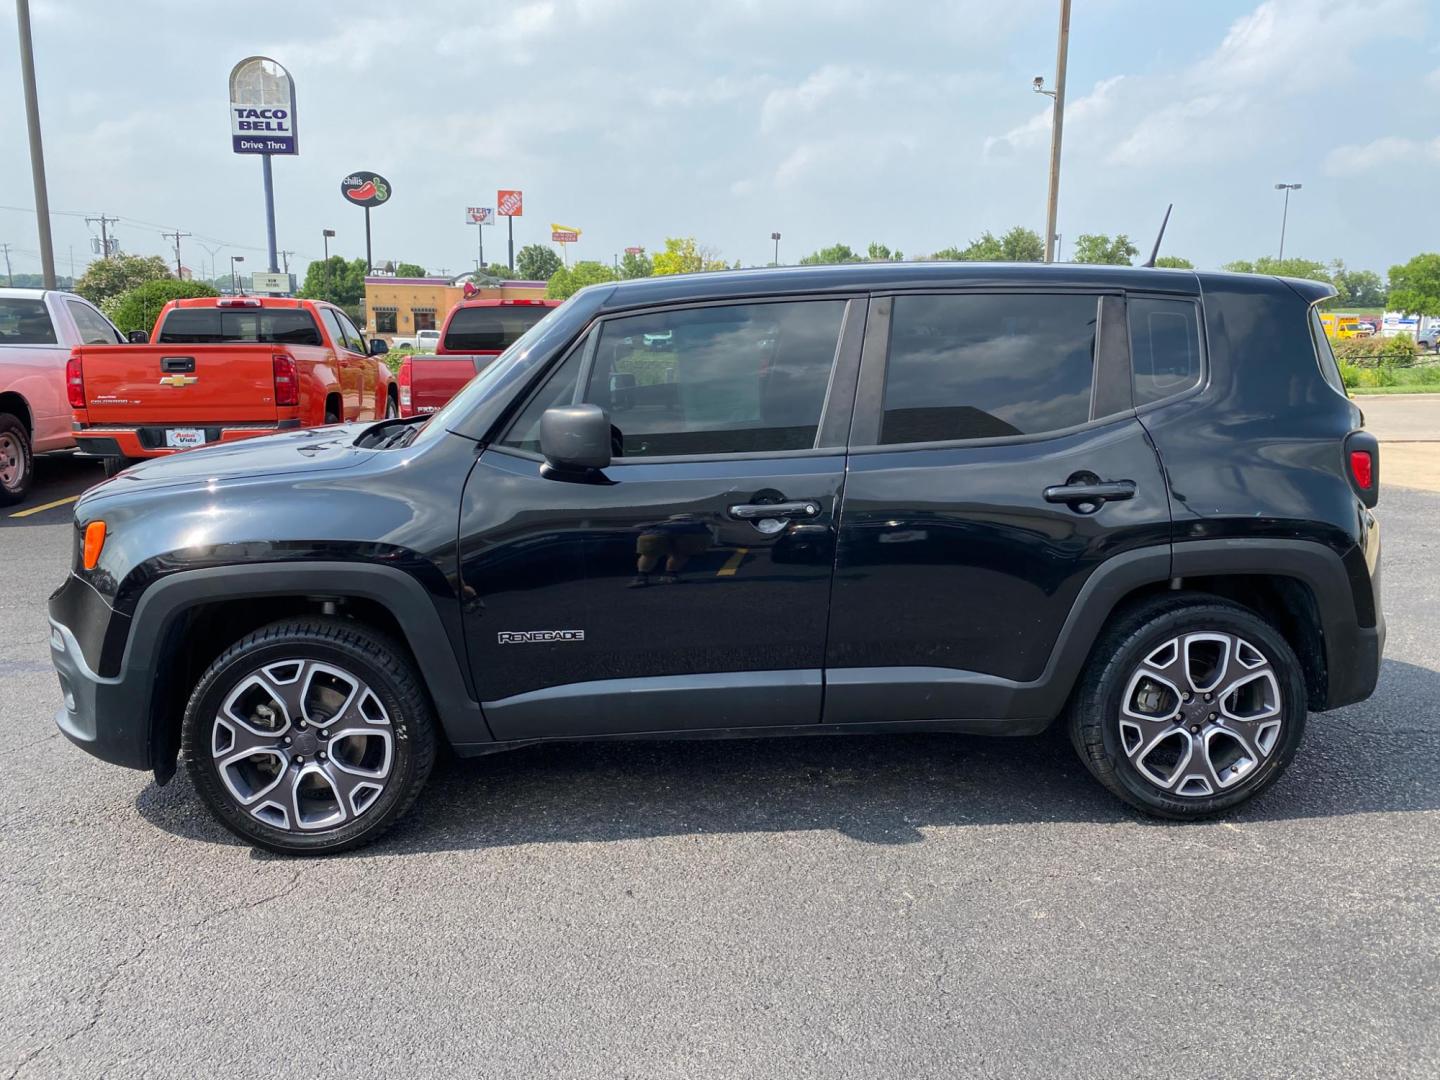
[210,660,395,832]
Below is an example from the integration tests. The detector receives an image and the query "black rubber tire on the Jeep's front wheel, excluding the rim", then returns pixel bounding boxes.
[180,618,436,855]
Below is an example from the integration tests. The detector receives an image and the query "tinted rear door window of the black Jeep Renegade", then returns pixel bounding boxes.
[880,294,1099,444]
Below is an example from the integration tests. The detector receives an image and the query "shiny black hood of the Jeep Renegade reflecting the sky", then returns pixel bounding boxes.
[81,423,374,505]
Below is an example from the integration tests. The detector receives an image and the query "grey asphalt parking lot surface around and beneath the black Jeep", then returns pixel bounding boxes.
[0,400,1440,1080]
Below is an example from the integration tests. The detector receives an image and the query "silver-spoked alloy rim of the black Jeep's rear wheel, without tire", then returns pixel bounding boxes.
[1117,631,1282,798]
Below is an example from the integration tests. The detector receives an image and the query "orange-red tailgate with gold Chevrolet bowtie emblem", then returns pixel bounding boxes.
[72,344,288,425]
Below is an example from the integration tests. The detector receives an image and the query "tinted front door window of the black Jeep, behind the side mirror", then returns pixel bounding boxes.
[585,300,845,458]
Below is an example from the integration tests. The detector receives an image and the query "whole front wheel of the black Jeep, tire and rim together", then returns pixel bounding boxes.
[181,618,435,854]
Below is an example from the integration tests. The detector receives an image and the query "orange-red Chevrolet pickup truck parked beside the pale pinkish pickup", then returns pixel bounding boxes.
[65,297,399,475]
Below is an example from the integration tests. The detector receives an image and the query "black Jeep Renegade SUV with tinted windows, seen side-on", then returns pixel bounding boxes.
[50,264,1385,852]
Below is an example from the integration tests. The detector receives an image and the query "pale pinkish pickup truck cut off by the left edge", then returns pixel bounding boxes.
[0,288,125,505]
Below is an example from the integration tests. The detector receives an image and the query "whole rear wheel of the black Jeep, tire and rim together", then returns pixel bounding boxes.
[1070,595,1306,818]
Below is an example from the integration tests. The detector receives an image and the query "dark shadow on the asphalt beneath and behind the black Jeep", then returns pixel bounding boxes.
[135,662,1440,858]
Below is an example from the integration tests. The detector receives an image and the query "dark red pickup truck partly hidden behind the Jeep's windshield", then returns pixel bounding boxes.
[395,300,562,416]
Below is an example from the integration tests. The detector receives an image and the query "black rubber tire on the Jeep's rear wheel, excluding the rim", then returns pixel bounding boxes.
[1068,593,1308,819]
